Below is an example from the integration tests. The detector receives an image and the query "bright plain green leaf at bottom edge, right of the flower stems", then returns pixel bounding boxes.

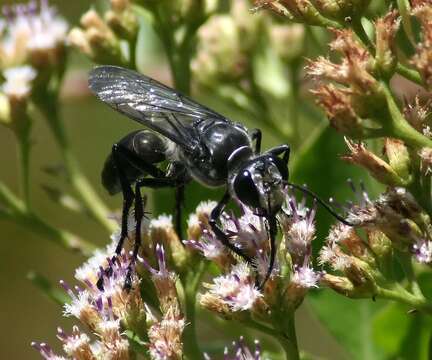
[308,289,383,360]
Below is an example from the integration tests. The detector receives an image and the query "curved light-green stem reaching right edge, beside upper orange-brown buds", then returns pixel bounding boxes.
[381,81,432,148]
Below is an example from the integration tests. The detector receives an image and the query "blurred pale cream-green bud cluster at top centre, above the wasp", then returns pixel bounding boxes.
[191,0,305,90]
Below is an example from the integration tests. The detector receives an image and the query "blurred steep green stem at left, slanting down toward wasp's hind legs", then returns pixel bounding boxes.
[38,94,116,232]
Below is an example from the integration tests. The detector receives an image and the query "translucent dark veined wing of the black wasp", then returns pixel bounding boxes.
[89,66,227,150]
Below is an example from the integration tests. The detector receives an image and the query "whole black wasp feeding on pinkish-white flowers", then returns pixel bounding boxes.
[89,66,352,287]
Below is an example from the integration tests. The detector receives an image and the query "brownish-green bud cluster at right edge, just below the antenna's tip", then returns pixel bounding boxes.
[319,179,432,298]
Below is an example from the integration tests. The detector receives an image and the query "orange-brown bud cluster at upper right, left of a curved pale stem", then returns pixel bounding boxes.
[307,29,385,139]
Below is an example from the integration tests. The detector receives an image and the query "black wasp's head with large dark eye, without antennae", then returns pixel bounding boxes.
[231,154,288,216]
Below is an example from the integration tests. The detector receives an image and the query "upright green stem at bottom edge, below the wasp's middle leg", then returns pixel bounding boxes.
[183,261,206,360]
